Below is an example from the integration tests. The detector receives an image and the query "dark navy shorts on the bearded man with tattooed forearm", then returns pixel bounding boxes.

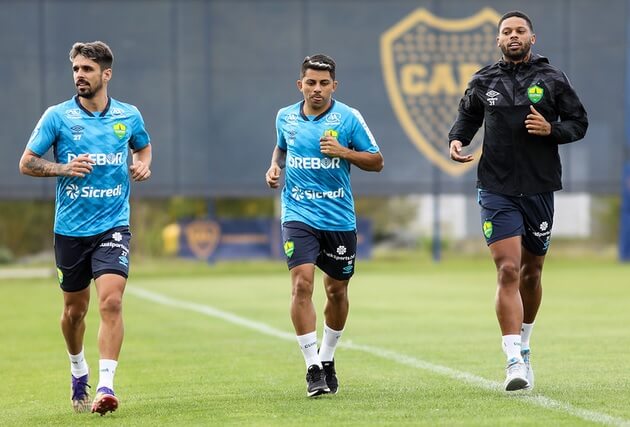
[55,226,131,292]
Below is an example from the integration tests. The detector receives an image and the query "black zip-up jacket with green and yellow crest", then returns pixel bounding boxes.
[448,54,588,196]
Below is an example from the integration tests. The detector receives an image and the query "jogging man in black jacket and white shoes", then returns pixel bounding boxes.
[448,11,588,391]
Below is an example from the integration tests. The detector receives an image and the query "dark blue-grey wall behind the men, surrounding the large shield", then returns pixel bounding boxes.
[0,0,628,198]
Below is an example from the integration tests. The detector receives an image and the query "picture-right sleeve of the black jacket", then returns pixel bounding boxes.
[550,73,588,144]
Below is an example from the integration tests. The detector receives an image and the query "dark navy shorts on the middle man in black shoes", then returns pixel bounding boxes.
[282,221,357,280]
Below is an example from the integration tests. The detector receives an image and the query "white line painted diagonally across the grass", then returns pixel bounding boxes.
[125,286,630,427]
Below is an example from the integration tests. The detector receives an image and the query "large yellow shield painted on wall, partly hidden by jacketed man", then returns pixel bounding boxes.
[381,8,500,176]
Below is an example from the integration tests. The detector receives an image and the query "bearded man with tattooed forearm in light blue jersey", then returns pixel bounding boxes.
[20,41,151,415]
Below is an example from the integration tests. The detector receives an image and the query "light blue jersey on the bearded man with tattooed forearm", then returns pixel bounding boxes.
[27,97,150,237]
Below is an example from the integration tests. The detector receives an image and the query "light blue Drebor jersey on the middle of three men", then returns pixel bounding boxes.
[276,100,379,231]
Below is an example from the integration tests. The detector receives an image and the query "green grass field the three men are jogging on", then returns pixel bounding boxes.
[0,257,630,426]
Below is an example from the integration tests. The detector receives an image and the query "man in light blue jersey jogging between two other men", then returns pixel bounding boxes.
[265,54,383,397]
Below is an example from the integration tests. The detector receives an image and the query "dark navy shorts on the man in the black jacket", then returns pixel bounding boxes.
[477,189,554,256]
